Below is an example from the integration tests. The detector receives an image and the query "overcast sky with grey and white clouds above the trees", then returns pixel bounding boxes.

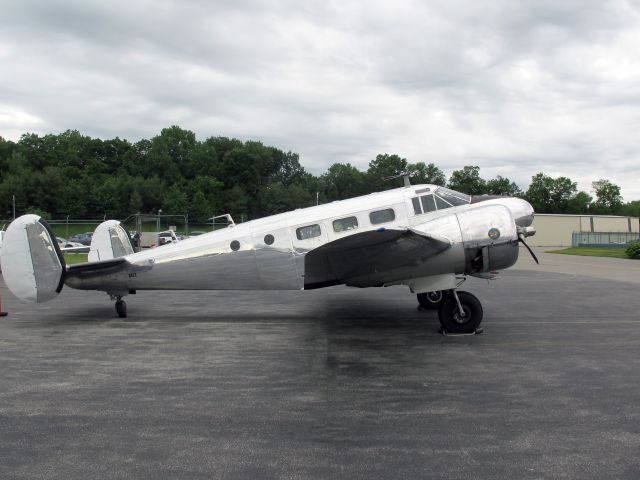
[0,0,640,201]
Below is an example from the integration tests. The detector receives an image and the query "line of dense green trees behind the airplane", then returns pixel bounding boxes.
[0,126,640,222]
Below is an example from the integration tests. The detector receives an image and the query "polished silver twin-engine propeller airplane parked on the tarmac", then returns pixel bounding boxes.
[0,185,535,333]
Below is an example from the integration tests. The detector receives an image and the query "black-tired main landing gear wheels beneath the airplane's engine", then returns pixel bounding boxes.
[418,289,483,335]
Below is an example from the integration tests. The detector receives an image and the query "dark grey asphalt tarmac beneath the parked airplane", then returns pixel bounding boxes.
[0,253,640,479]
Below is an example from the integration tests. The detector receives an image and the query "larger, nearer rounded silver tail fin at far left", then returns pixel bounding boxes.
[0,215,66,303]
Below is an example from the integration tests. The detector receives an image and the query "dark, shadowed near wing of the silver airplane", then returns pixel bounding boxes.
[304,228,452,289]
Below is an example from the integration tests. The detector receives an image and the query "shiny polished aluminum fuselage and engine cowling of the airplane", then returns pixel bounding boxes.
[65,185,533,294]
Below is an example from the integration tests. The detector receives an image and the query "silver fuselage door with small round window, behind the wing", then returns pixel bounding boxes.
[251,216,303,290]
